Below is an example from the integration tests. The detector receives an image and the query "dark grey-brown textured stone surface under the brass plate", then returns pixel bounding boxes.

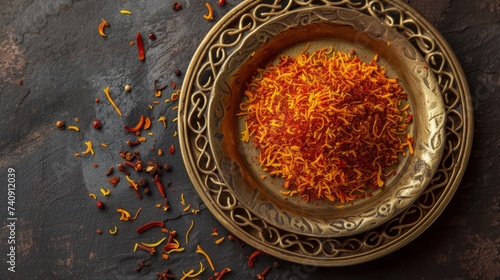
[0,0,500,279]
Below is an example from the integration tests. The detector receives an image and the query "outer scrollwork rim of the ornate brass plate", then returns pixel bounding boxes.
[179,0,473,266]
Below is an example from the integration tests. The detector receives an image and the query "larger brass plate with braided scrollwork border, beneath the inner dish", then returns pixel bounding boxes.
[179,0,472,266]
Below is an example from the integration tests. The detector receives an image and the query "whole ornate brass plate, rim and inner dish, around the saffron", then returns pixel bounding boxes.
[179,0,472,266]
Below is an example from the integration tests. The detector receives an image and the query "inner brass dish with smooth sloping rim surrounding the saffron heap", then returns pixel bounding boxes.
[207,7,445,237]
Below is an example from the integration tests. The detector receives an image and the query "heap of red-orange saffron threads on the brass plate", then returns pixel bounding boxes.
[237,49,413,203]
